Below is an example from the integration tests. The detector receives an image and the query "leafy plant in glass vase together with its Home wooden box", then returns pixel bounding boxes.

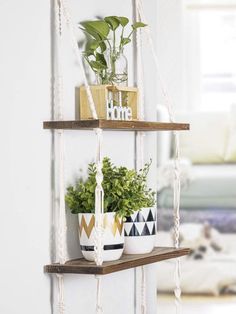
[78,16,146,120]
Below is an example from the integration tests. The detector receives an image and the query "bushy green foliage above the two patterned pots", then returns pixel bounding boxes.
[65,157,155,217]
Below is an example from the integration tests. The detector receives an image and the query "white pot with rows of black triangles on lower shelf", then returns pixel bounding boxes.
[124,207,156,254]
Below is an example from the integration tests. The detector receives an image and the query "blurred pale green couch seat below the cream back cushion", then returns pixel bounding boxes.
[158,164,236,208]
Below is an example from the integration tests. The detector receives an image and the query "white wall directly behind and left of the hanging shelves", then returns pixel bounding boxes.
[0,0,164,314]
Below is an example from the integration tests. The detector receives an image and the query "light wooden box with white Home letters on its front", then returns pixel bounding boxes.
[79,85,138,121]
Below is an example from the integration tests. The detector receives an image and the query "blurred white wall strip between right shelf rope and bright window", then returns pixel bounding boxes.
[156,0,185,110]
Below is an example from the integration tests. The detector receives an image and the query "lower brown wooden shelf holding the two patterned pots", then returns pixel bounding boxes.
[44,247,190,275]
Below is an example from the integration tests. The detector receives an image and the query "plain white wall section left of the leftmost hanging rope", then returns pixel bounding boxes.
[0,0,50,314]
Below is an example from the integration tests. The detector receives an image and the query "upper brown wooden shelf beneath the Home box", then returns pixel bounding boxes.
[43,119,189,131]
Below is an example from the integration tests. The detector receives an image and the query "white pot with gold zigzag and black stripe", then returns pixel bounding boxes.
[79,212,124,262]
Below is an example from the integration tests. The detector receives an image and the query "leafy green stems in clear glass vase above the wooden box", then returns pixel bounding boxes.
[80,16,146,85]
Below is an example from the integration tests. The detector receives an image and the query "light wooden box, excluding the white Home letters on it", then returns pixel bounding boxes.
[79,85,138,120]
